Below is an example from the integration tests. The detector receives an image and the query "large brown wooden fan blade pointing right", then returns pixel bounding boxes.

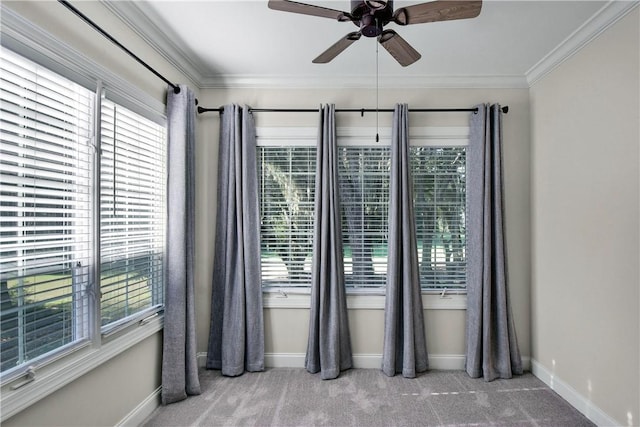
[393,0,482,25]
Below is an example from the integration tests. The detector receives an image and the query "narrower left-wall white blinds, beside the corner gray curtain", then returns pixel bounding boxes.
[100,99,167,326]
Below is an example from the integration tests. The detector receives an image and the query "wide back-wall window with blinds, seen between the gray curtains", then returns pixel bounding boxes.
[258,128,468,292]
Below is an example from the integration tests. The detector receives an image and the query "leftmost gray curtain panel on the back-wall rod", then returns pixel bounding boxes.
[207,105,264,376]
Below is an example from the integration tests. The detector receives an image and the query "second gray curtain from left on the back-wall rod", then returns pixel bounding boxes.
[305,105,352,380]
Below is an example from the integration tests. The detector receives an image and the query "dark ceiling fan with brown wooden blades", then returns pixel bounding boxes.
[268,0,482,67]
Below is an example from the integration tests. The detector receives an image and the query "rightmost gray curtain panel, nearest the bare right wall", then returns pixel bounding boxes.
[466,104,522,381]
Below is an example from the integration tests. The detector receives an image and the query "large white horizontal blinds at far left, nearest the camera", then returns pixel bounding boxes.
[0,48,94,373]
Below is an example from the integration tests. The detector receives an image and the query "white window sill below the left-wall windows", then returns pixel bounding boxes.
[0,316,164,422]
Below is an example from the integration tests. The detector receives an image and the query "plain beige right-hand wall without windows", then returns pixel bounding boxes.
[531,8,640,425]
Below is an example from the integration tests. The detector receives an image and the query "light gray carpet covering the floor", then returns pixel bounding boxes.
[143,368,594,427]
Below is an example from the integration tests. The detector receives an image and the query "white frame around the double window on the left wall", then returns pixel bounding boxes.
[0,4,166,422]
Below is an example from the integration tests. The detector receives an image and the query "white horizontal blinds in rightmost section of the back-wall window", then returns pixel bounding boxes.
[411,146,466,289]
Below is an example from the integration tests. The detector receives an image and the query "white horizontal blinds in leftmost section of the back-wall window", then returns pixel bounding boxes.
[258,146,316,287]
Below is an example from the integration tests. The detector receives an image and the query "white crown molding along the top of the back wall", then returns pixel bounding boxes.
[200,75,529,89]
